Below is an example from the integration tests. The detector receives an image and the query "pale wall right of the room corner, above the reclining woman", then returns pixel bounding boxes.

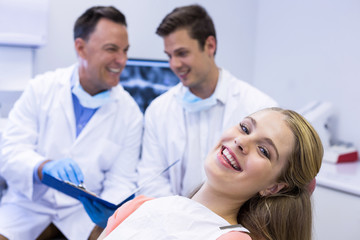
[254,0,360,149]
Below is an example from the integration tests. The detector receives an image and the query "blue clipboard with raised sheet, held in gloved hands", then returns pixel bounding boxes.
[41,159,180,210]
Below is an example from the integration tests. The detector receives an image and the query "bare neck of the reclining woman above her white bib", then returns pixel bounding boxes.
[191,183,245,225]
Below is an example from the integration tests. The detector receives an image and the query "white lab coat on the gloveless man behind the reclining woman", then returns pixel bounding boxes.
[138,69,278,197]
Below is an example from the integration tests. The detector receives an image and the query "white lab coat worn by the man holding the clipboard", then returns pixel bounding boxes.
[0,65,143,239]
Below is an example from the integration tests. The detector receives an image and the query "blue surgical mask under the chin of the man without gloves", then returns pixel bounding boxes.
[181,89,216,112]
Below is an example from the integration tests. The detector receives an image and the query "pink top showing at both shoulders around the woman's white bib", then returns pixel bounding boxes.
[105,195,251,240]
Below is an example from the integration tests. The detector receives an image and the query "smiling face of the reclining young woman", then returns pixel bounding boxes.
[205,110,295,200]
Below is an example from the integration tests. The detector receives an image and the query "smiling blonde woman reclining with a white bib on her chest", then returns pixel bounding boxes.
[100,108,323,240]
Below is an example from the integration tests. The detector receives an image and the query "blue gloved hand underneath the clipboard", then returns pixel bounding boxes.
[79,196,116,228]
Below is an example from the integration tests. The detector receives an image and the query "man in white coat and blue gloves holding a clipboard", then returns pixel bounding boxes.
[0,6,143,239]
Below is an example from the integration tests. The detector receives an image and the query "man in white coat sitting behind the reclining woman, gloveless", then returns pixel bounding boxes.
[138,5,277,197]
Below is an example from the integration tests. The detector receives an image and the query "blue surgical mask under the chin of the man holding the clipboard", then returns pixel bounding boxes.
[72,81,110,109]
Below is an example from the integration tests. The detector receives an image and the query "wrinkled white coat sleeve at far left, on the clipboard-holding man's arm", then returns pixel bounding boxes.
[0,79,45,199]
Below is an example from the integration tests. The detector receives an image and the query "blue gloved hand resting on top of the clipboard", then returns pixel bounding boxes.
[42,158,84,185]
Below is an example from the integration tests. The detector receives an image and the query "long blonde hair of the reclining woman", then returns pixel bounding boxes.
[238,108,323,240]
